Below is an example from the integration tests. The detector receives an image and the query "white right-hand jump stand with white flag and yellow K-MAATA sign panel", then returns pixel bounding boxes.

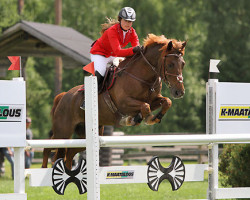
[206,59,250,200]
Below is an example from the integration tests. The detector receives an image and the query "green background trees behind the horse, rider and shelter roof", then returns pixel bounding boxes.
[0,0,250,136]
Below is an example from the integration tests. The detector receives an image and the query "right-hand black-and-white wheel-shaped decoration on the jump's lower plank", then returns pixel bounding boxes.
[148,156,185,191]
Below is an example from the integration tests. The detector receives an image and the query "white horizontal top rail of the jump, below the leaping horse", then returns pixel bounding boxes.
[26,134,250,148]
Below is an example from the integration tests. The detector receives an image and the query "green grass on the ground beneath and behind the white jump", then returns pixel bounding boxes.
[0,161,208,200]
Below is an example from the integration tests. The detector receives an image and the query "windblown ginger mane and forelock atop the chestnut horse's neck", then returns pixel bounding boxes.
[143,33,185,55]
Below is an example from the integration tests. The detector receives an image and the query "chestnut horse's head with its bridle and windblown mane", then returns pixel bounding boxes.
[144,34,186,98]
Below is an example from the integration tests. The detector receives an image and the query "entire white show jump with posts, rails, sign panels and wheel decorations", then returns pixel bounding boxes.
[0,61,250,200]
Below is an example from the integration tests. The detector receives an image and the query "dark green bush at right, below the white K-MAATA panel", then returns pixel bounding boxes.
[219,144,250,187]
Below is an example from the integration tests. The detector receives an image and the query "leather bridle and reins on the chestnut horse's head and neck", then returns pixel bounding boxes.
[140,51,183,88]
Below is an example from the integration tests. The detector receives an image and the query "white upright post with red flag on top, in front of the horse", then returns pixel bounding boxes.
[84,76,100,200]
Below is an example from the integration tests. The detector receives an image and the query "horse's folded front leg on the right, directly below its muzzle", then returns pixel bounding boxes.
[145,95,172,125]
